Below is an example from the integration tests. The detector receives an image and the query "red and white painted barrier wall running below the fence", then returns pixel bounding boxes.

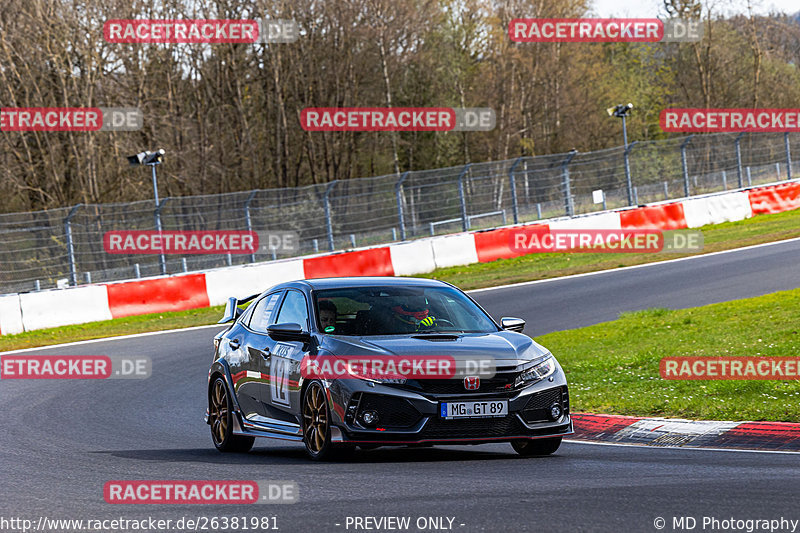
[0,181,800,334]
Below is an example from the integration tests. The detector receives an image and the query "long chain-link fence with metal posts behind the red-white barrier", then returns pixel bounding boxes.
[0,133,800,293]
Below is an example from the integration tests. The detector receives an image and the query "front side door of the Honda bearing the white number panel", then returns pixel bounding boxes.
[263,289,311,418]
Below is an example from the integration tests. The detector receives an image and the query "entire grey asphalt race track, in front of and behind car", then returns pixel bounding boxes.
[0,240,800,532]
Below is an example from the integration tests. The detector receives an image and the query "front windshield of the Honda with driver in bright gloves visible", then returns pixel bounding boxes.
[315,286,498,336]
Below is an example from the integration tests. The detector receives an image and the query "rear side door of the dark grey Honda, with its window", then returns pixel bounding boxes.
[237,290,284,419]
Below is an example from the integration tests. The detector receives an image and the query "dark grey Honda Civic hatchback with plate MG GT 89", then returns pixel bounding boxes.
[205,277,572,460]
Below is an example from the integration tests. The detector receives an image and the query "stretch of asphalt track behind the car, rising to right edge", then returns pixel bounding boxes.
[471,239,800,336]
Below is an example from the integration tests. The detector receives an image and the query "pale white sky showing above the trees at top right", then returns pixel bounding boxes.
[594,0,800,18]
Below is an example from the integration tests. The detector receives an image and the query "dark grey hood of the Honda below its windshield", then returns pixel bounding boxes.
[321,331,549,365]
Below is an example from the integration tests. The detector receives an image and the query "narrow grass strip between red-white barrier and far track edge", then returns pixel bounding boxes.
[0,209,800,351]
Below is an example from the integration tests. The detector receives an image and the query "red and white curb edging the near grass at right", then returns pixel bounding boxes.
[570,413,800,452]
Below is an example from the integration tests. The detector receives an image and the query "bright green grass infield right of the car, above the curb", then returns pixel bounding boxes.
[536,289,800,422]
